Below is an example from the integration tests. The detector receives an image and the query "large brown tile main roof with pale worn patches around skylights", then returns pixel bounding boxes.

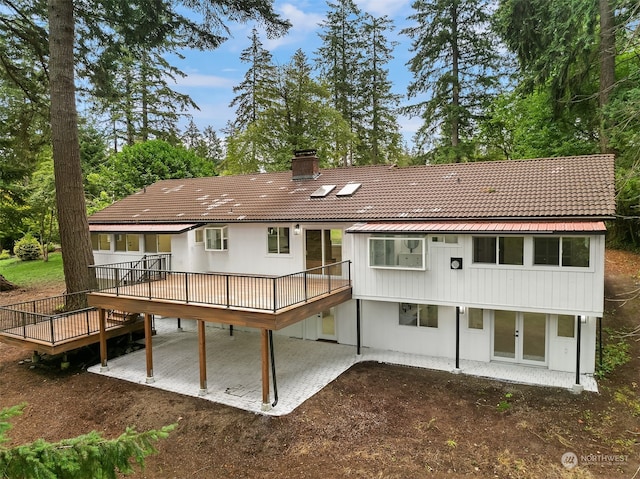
[89,155,615,224]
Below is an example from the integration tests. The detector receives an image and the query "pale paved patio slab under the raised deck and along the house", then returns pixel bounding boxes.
[89,318,598,416]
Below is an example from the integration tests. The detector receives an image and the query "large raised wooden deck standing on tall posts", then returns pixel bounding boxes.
[88,273,351,330]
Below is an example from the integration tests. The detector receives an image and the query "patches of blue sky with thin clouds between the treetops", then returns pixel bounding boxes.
[171,0,419,141]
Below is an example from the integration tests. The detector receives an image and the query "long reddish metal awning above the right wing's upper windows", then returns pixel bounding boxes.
[346,221,607,234]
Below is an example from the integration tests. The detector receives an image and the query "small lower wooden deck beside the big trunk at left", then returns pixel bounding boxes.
[0,309,144,355]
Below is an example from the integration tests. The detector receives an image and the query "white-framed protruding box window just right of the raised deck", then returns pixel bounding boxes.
[369,236,426,270]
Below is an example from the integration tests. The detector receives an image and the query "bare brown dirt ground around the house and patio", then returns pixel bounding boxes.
[0,251,640,479]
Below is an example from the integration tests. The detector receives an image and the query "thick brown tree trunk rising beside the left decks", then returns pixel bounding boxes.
[48,0,95,293]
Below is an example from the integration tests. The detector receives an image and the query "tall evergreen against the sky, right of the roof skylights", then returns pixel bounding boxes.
[402,0,499,162]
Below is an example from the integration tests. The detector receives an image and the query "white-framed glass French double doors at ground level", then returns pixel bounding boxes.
[492,311,548,366]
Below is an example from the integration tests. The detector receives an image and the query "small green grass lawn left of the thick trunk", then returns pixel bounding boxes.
[0,252,64,287]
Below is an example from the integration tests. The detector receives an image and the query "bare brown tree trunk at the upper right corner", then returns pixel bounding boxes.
[598,0,616,153]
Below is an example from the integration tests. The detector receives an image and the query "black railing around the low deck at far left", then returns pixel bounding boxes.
[0,291,96,344]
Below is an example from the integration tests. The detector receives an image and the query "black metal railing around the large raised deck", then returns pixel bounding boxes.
[92,261,351,312]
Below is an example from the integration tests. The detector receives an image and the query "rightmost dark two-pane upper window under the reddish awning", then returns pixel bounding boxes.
[533,236,590,268]
